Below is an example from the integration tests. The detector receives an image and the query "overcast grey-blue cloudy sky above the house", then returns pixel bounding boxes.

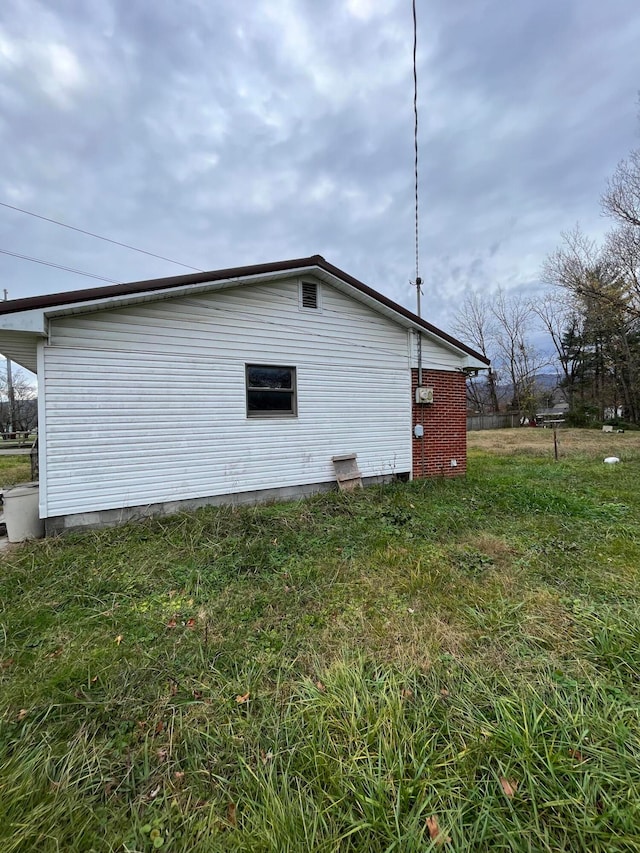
[0,0,640,336]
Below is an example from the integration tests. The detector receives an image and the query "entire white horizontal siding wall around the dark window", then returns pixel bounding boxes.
[43,281,411,516]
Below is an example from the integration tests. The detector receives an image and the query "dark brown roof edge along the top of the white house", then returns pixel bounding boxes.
[0,255,490,366]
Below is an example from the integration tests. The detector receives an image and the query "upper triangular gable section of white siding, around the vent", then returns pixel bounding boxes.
[50,281,408,367]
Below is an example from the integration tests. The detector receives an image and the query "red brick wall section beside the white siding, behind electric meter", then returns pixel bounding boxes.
[411,370,467,478]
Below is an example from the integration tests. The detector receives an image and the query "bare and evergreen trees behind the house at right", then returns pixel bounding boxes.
[455,111,640,425]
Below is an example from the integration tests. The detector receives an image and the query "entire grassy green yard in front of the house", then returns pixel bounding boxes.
[0,429,640,853]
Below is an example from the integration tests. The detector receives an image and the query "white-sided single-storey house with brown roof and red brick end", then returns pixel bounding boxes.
[0,255,488,532]
